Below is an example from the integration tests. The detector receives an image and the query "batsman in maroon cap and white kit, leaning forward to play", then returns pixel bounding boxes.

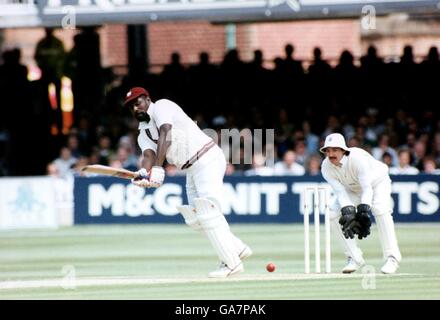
[124,87,252,278]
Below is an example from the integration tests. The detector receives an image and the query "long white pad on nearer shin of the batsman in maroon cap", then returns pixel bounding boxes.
[194,198,241,269]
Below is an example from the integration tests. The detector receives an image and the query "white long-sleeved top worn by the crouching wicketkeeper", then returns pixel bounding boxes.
[321,148,389,207]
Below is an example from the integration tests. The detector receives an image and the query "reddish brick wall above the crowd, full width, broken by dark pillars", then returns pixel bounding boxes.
[0,20,440,75]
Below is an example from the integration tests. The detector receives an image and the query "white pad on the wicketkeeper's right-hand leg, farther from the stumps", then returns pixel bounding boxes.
[374,214,402,262]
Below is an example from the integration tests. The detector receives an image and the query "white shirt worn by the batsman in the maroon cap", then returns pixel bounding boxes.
[138,99,213,169]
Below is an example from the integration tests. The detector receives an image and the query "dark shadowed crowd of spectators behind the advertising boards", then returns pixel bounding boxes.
[0,28,440,177]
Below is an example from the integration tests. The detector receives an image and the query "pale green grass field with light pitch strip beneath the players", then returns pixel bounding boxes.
[0,223,440,300]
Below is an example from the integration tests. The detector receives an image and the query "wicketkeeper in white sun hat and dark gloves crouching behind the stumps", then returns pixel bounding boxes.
[320,133,402,274]
